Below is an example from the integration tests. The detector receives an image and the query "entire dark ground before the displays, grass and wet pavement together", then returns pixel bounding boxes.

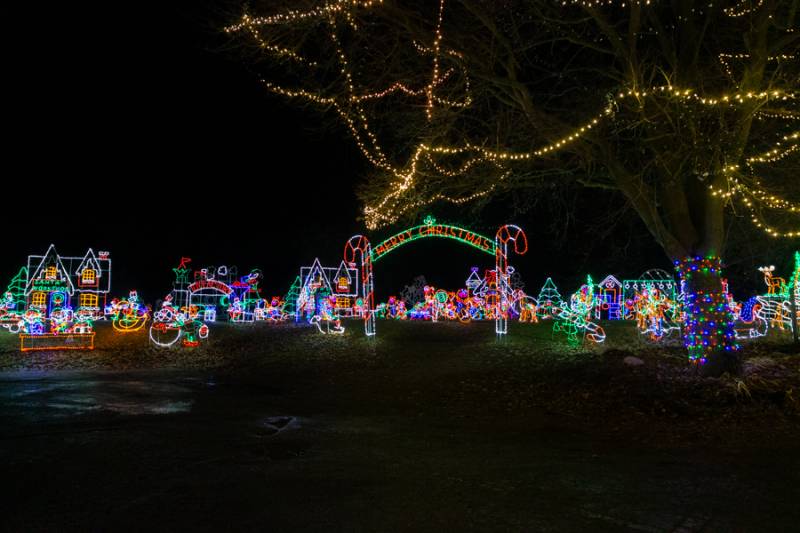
[0,322,800,532]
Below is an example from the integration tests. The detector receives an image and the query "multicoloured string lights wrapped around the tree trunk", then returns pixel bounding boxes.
[675,256,739,364]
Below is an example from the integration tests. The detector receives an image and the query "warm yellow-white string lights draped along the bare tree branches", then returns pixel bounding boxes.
[225,0,800,237]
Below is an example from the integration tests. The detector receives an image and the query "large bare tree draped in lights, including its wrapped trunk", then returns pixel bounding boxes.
[227,0,800,375]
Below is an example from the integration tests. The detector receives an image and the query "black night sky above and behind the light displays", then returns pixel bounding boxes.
[0,1,788,302]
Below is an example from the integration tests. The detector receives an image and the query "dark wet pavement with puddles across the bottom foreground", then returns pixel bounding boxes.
[0,371,800,531]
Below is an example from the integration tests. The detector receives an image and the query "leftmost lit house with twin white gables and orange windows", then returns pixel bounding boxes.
[25,244,111,319]
